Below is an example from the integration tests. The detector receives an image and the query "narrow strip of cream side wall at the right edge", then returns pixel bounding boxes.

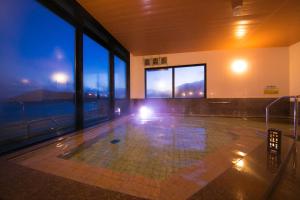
[289,42,300,95]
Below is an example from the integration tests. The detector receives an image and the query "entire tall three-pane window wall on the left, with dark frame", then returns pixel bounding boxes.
[0,0,129,154]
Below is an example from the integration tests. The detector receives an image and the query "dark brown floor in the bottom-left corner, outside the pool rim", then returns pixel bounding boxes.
[0,159,144,200]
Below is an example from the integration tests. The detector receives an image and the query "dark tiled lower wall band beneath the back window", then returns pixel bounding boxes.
[131,98,291,117]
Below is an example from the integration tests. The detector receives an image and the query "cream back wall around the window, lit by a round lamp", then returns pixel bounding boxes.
[131,47,289,99]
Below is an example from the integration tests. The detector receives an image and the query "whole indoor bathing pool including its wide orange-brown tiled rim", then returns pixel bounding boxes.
[10,116,292,199]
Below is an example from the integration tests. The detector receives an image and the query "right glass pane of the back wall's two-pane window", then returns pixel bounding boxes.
[175,65,205,98]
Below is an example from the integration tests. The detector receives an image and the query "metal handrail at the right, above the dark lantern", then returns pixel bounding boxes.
[266,95,300,140]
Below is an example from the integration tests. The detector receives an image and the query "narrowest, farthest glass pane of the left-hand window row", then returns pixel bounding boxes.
[114,56,126,99]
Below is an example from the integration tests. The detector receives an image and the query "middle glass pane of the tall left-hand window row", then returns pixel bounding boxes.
[83,35,110,126]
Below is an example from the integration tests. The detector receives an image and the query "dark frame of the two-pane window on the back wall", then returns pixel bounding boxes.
[144,63,207,99]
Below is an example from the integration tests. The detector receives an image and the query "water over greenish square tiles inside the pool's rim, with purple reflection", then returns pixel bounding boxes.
[65,117,237,180]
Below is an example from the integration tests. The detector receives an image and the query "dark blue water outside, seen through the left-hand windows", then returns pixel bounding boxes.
[0,99,108,153]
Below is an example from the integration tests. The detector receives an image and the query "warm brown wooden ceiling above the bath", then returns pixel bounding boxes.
[78,0,300,55]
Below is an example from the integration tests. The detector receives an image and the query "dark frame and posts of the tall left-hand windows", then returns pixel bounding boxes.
[0,0,130,155]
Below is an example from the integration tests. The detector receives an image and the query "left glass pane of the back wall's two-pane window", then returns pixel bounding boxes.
[146,68,172,98]
